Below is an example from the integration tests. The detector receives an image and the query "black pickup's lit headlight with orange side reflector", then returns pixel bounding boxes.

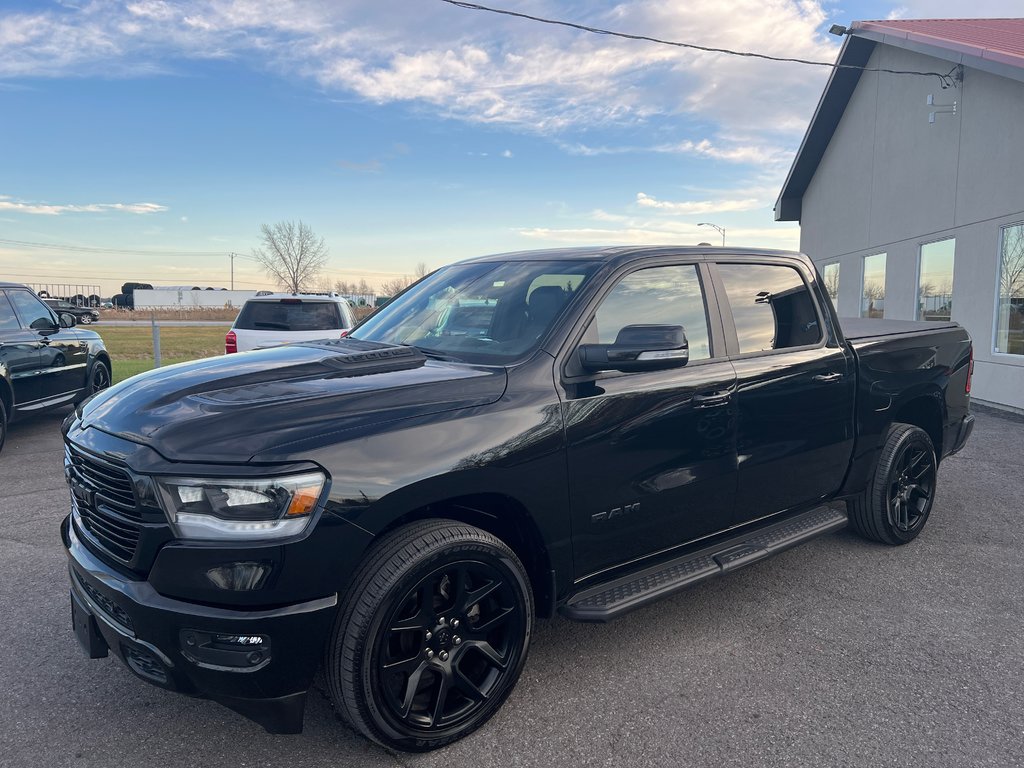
[156,472,327,540]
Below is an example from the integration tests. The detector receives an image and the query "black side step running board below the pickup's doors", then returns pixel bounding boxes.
[561,505,847,622]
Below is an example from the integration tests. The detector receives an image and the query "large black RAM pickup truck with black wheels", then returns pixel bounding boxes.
[60,248,973,751]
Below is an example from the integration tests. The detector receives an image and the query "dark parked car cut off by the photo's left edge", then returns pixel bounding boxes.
[0,283,111,450]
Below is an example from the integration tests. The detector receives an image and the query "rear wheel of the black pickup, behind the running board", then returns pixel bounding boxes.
[850,424,938,546]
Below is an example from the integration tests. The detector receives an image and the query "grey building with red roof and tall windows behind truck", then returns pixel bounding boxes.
[775,18,1024,411]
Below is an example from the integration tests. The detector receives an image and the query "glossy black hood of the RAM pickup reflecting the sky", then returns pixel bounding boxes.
[81,339,507,463]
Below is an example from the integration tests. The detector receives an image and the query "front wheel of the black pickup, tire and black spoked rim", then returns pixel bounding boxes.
[325,520,534,752]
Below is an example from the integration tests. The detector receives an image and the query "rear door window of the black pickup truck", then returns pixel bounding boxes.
[718,264,821,354]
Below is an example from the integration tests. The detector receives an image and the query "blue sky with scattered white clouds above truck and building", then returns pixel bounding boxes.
[0,0,1020,294]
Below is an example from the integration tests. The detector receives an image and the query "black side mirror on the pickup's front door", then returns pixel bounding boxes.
[580,326,690,373]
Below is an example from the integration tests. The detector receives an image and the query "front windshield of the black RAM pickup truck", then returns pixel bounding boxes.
[352,261,596,365]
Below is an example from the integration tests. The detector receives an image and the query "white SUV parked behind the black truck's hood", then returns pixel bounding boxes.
[224,293,355,353]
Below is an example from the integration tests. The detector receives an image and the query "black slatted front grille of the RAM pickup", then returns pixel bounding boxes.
[65,443,141,563]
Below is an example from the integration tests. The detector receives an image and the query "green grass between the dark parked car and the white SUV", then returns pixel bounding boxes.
[93,325,228,384]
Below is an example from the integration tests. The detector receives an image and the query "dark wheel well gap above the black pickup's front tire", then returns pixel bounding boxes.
[376,493,556,617]
